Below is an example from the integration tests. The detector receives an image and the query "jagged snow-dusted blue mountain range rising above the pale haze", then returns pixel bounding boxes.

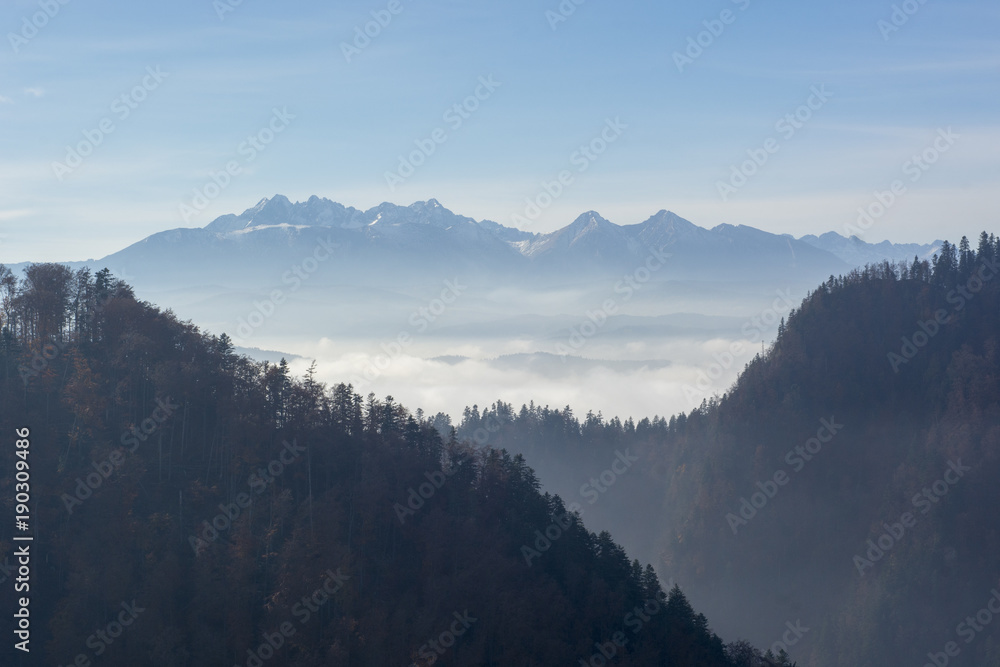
[39,195,939,287]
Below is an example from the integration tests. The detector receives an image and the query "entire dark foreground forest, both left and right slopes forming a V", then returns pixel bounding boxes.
[0,234,1000,667]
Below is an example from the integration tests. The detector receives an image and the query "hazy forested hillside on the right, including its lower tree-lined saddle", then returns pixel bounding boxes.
[458,233,1000,667]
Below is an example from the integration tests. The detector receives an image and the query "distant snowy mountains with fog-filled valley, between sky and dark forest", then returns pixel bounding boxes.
[12,195,940,428]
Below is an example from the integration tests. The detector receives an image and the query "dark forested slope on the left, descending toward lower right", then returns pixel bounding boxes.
[0,264,777,667]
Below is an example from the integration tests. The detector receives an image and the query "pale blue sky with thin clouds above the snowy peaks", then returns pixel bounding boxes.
[0,0,1000,263]
